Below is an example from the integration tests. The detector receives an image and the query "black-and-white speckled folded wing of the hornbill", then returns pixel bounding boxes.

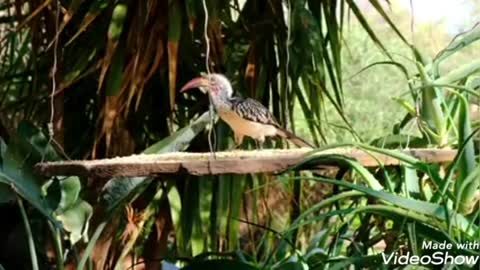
[230,97,278,126]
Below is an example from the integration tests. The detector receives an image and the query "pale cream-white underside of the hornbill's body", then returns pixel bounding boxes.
[218,110,277,140]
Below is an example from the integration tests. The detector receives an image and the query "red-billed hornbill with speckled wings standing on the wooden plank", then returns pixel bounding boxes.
[180,74,313,148]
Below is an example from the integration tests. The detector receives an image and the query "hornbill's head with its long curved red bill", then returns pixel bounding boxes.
[180,73,233,97]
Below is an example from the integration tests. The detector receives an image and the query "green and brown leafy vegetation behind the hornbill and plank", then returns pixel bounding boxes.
[0,0,480,269]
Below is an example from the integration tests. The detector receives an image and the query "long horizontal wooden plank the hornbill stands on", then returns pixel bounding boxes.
[35,148,457,178]
